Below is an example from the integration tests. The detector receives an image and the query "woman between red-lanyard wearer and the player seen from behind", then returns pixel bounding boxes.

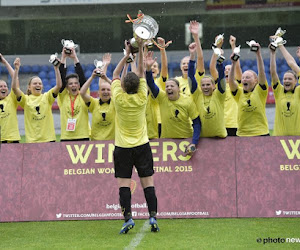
[80,54,115,141]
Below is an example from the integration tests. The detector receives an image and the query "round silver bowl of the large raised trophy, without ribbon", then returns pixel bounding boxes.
[133,15,158,40]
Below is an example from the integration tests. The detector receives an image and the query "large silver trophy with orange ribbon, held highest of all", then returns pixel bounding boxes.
[126,11,158,54]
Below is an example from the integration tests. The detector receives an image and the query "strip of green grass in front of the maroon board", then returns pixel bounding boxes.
[0,218,300,249]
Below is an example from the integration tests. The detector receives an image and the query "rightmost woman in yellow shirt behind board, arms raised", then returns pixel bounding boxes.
[270,42,300,136]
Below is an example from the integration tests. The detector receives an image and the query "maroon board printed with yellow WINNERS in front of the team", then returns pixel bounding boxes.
[0,137,300,222]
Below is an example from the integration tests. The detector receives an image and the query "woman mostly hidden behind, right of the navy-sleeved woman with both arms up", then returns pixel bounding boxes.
[209,35,242,136]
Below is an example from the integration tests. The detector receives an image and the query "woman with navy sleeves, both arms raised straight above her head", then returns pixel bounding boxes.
[188,41,227,138]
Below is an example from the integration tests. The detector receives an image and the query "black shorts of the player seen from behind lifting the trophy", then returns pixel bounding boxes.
[114,142,154,178]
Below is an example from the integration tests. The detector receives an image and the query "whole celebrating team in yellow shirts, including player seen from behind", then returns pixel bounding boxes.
[0,21,300,233]
